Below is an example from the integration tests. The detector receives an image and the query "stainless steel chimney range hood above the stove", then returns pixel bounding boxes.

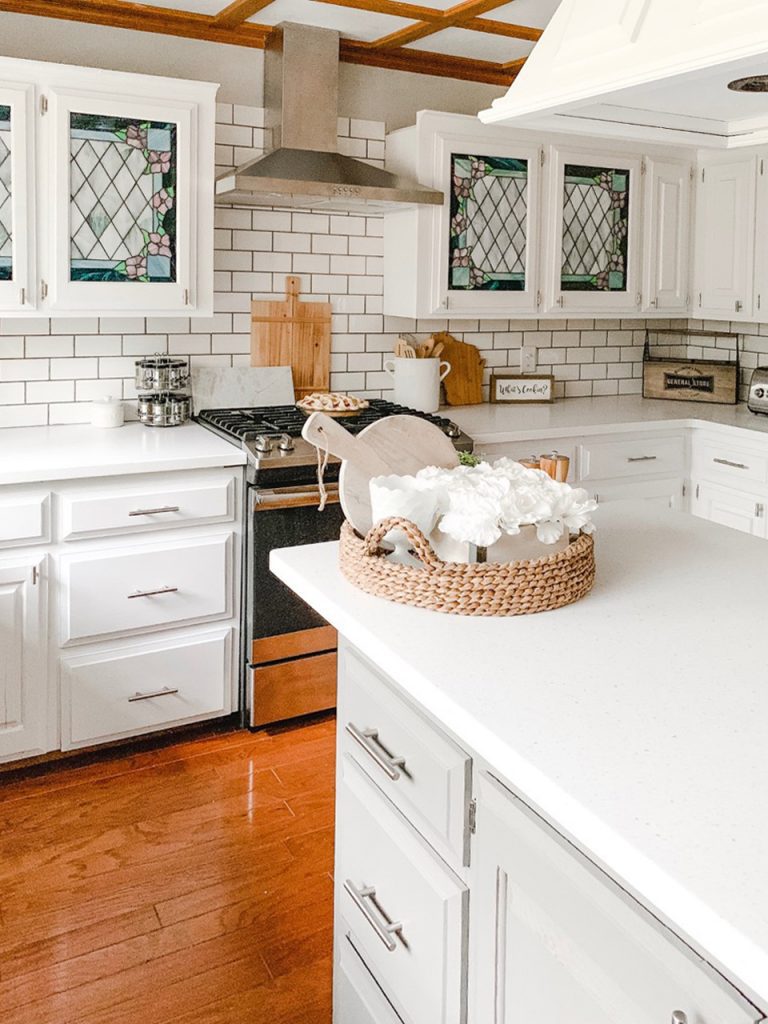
[216,23,444,213]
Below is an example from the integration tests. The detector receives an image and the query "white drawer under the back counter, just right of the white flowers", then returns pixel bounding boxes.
[579,437,685,480]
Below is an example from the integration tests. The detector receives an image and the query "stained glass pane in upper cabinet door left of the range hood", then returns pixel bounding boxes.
[70,114,176,283]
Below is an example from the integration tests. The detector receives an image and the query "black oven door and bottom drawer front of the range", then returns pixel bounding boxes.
[246,484,344,727]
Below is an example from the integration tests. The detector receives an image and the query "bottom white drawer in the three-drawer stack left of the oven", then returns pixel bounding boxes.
[61,629,232,750]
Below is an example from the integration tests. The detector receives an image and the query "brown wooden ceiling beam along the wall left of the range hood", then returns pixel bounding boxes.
[0,0,271,49]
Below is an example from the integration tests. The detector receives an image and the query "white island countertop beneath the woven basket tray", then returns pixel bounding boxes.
[271,502,768,1012]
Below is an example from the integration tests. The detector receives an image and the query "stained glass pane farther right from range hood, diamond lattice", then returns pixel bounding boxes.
[560,164,630,292]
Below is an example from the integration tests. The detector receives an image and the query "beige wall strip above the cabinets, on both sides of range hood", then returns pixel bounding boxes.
[0,12,505,130]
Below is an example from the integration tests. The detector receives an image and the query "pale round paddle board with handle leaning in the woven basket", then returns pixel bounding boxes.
[301,413,459,537]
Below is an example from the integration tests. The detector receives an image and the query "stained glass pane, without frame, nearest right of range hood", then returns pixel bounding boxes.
[449,154,528,291]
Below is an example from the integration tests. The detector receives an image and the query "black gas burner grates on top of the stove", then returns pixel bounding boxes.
[198,398,462,438]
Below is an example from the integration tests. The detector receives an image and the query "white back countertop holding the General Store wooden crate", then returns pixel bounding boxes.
[448,395,768,444]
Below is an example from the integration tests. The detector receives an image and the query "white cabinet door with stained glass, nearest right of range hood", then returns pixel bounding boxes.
[435,137,541,316]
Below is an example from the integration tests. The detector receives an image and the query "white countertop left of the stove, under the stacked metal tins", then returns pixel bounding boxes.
[0,423,246,484]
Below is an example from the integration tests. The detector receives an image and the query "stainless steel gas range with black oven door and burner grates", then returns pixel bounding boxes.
[198,398,472,728]
